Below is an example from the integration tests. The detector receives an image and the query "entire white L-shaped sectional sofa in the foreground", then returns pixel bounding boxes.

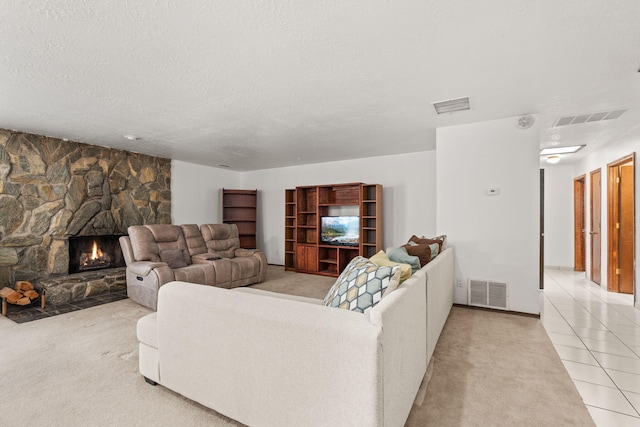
[137,248,453,426]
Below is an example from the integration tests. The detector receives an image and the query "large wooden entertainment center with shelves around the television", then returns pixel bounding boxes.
[284,182,383,277]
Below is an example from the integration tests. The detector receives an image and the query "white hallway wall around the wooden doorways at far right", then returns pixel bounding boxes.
[574,128,640,306]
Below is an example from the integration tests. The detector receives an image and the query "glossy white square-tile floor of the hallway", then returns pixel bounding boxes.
[540,269,640,427]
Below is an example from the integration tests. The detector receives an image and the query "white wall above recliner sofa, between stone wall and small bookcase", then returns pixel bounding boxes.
[171,160,241,224]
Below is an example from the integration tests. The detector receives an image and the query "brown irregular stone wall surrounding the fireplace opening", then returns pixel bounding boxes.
[0,129,171,288]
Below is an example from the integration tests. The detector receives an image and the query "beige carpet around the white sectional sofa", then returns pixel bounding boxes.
[0,266,592,427]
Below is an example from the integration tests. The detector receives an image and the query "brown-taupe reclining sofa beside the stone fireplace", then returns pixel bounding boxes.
[120,224,267,310]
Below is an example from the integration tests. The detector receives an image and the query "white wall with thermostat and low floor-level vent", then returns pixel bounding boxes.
[436,117,540,314]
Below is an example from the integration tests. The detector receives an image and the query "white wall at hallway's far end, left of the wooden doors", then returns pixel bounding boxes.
[544,165,580,269]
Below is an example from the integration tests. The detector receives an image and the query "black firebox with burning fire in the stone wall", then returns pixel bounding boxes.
[69,236,125,274]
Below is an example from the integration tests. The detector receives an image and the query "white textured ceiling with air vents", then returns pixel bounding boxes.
[0,0,640,171]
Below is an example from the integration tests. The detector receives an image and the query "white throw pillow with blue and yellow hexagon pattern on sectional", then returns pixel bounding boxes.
[323,256,400,313]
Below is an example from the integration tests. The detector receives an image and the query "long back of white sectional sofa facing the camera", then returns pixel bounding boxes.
[158,282,384,426]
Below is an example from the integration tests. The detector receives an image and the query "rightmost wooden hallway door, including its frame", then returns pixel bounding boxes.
[608,155,635,294]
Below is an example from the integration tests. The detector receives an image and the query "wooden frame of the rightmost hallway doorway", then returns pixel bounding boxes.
[607,153,636,292]
